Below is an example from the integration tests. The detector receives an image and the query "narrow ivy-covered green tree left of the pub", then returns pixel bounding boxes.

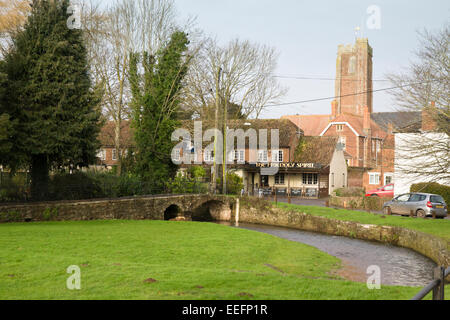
[130,31,189,183]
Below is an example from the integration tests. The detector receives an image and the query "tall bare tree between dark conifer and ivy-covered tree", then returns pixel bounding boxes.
[83,0,176,175]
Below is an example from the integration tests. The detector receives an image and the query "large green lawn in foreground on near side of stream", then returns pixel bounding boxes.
[0,221,432,300]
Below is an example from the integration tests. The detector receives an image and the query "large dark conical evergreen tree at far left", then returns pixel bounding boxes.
[0,0,100,200]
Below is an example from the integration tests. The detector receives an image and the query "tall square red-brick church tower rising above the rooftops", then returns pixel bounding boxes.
[333,39,373,117]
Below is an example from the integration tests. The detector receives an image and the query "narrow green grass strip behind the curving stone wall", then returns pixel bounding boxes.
[277,203,450,244]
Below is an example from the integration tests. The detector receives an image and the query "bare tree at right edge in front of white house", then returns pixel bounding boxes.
[388,25,450,183]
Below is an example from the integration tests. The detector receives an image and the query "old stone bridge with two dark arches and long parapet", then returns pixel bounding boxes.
[0,195,239,223]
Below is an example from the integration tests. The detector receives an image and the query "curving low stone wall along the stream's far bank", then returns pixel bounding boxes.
[239,198,450,267]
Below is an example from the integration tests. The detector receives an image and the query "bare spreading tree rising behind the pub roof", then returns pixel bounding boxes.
[184,39,286,118]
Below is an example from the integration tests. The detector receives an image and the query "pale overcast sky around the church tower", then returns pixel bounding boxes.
[101,0,450,118]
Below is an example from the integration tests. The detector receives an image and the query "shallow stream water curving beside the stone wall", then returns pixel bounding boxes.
[220,223,436,287]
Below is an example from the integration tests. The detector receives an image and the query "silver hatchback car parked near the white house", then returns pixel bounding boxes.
[383,193,448,219]
